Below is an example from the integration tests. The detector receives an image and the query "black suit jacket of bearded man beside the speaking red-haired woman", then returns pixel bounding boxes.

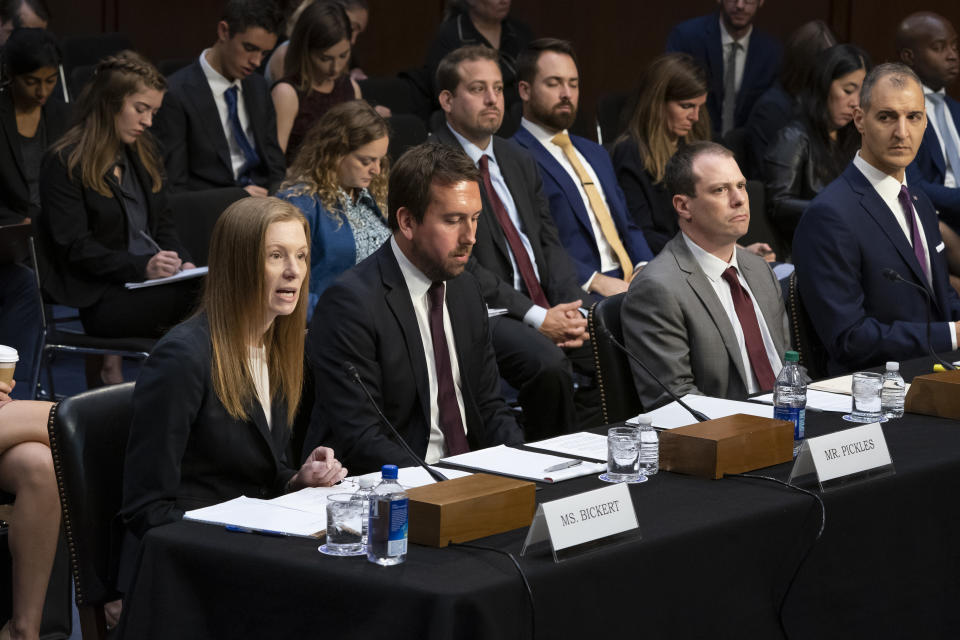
[304,242,523,473]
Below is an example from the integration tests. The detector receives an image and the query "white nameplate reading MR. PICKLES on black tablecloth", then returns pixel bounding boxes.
[790,422,893,488]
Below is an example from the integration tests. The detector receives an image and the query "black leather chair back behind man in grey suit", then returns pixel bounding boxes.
[588,293,642,424]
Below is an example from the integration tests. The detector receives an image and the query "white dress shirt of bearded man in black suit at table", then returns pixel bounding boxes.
[390,237,467,464]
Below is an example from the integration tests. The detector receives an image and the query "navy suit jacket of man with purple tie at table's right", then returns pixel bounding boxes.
[793,163,960,373]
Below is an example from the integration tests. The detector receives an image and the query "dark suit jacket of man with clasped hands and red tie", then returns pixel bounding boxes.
[433,123,589,320]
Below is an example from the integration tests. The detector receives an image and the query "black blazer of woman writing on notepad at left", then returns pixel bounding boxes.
[35,144,190,308]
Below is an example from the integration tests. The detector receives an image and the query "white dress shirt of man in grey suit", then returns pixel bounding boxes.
[683,233,783,394]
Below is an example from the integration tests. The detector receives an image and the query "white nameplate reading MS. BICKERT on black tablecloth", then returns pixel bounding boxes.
[520,483,637,557]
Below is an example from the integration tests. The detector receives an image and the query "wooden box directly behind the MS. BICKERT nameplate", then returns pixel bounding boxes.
[407,473,536,547]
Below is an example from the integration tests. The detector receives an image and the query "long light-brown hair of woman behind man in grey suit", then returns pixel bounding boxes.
[620,53,710,182]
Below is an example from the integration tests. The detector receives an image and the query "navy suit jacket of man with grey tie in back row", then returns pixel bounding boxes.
[667,13,783,133]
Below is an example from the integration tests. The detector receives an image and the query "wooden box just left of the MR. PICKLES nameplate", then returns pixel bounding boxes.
[660,413,793,479]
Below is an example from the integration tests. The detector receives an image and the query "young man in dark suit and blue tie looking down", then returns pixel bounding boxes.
[154,0,286,196]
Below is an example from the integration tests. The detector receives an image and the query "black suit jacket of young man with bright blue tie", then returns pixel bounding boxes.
[154,60,287,193]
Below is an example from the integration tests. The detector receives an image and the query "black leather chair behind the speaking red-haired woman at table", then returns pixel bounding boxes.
[49,382,133,640]
